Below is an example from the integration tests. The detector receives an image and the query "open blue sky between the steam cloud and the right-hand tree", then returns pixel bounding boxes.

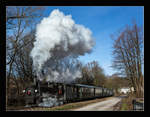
[44,6,144,75]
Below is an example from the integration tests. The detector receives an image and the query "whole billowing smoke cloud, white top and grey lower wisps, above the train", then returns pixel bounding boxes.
[31,9,94,82]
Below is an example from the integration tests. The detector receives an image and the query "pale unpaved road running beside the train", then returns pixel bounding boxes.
[73,96,125,111]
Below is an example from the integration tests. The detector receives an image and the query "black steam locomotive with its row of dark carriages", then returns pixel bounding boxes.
[23,82,114,107]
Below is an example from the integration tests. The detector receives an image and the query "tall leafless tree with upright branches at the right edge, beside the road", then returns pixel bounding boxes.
[113,24,144,97]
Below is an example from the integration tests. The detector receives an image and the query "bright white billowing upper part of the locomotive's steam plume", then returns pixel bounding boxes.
[31,9,94,82]
